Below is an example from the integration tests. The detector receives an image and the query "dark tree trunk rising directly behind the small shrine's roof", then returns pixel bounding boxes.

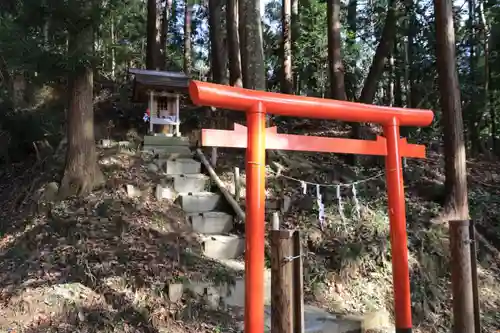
[146,0,161,69]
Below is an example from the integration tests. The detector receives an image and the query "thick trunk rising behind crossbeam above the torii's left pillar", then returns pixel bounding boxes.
[240,0,266,90]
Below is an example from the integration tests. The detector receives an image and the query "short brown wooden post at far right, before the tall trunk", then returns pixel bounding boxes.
[449,220,475,333]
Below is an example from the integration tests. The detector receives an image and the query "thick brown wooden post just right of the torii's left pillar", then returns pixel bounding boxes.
[271,216,294,333]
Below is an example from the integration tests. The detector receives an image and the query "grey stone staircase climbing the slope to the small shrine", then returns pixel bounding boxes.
[143,136,372,333]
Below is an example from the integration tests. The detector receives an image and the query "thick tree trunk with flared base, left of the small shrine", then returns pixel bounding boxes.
[59,18,104,199]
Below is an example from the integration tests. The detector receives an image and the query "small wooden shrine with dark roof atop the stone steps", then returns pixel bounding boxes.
[129,69,189,136]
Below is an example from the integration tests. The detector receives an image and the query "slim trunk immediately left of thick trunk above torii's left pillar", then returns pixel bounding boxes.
[226,0,243,87]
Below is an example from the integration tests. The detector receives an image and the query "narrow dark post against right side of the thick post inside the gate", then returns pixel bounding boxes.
[293,230,304,333]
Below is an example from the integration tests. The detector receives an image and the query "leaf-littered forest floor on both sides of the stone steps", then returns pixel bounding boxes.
[0,95,500,333]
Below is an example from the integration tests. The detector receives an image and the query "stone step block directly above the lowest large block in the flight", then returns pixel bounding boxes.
[187,212,233,235]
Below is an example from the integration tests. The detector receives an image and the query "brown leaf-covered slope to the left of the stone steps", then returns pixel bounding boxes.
[0,147,242,333]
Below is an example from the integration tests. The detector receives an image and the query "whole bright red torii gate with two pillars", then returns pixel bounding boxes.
[189,81,434,333]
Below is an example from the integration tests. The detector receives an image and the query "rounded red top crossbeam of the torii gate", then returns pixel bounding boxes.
[189,81,434,126]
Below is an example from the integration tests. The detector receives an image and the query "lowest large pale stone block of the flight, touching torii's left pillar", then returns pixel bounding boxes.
[202,235,245,259]
